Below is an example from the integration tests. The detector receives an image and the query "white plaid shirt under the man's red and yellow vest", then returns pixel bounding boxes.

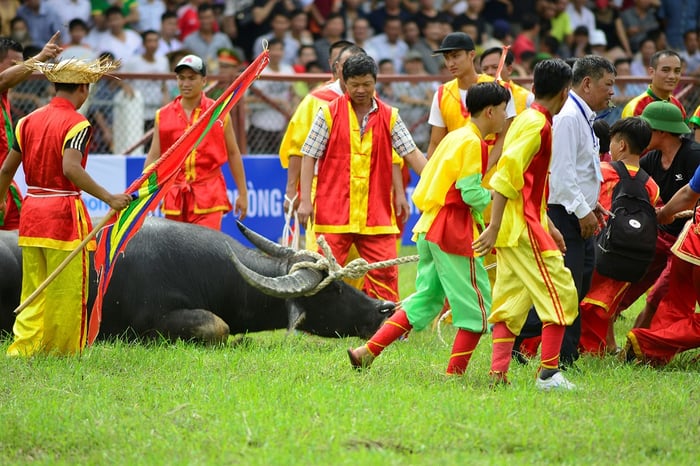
[301,99,416,159]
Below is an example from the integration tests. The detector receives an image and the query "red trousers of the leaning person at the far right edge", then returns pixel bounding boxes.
[627,256,700,365]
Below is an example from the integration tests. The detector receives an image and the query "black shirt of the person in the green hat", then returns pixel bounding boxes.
[639,138,700,236]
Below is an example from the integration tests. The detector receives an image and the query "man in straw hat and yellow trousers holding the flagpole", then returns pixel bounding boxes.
[0,59,131,356]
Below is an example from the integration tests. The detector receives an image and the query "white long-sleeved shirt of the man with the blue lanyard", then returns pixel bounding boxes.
[548,91,603,218]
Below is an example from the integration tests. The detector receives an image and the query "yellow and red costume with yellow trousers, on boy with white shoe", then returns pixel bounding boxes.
[489,103,578,374]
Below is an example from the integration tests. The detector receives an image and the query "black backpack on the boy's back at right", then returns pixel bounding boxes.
[596,161,657,282]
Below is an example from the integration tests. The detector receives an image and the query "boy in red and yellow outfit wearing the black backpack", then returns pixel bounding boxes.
[579,117,659,354]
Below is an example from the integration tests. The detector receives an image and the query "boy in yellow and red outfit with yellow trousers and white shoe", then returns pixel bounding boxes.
[473,59,578,390]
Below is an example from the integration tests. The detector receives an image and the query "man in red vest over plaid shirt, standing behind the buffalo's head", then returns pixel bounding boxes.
[298,54,426,301]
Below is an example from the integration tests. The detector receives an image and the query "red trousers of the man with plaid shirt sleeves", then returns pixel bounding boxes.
[316,233,399,302]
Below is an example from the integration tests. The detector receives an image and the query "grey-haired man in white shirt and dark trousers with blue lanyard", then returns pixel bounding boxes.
[515,55,616,366]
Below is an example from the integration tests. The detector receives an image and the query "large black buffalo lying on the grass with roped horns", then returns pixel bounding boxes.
[0,218,394,342]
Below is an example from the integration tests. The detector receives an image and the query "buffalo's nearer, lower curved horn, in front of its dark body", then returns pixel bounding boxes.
[229,242,323,299]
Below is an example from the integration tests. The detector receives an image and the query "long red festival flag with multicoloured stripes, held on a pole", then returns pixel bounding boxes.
[88,50,269,344]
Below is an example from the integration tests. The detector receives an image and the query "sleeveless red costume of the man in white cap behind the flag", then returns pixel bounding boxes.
[156,94,232,230]
